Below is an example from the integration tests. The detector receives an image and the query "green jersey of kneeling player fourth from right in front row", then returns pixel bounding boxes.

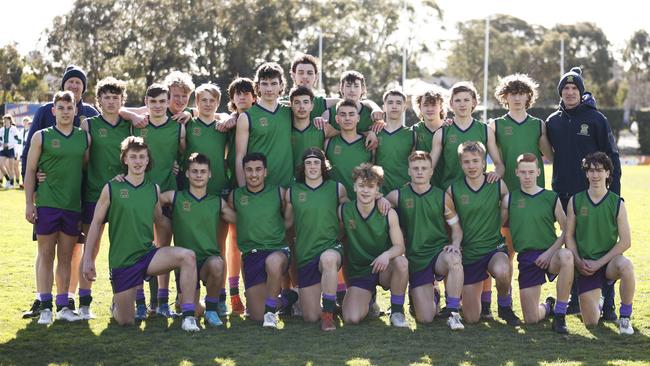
[397,184,449,272]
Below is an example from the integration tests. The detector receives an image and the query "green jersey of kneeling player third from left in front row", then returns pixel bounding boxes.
[233,185,287,255]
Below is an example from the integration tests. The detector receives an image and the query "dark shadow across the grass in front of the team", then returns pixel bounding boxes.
[0,316,650,365]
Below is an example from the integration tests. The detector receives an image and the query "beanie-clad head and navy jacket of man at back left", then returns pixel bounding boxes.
[21,65,99,180]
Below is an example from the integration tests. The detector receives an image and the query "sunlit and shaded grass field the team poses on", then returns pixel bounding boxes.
[0,167,650,365]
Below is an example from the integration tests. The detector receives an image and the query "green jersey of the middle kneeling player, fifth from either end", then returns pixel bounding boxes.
[341,201,391,278]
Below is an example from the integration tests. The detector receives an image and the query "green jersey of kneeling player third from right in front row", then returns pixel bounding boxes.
[451,178,504,264]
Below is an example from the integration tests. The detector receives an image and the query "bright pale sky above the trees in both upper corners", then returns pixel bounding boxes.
[0,0,650,54]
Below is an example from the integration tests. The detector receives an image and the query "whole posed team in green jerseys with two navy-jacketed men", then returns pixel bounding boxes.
[13,55,635,334]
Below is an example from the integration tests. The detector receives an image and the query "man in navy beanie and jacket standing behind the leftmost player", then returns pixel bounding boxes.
[21,65,99,318]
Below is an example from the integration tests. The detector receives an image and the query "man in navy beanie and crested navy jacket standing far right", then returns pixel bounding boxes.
[546,67,621,320]
